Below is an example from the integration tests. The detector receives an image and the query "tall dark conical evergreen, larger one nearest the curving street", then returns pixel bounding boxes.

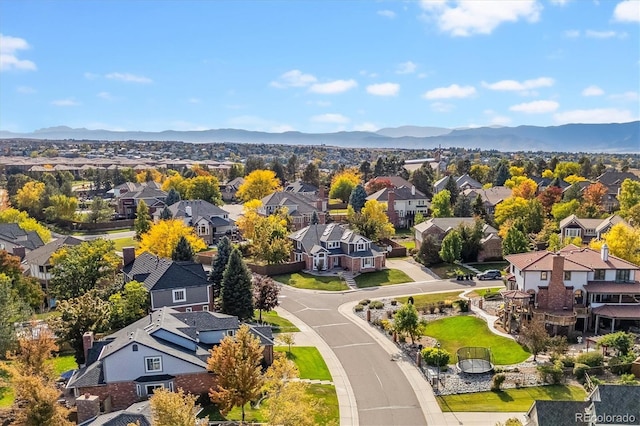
[222,248,254,321]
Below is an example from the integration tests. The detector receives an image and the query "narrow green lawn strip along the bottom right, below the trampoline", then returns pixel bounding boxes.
[436,385,586,412]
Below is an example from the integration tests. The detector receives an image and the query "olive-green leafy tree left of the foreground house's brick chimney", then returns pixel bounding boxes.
[49,290,111,364]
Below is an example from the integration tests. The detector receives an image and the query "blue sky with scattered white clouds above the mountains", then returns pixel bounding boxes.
[0,0,640,132]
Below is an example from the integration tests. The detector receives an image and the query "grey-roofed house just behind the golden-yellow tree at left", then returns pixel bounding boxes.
[152,200,236,245]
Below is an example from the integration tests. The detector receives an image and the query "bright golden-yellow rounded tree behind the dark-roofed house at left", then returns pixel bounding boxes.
[136,219,207,258]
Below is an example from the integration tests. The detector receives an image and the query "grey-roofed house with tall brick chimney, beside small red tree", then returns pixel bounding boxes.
[367,184,431,228]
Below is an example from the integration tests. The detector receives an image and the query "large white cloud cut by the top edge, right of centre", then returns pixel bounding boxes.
[420,0,542,37]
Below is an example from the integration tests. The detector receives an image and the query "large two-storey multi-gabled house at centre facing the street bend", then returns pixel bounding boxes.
[289,223,385,272]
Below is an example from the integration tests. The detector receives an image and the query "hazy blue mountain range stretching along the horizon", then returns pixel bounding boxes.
[0,121,640,153]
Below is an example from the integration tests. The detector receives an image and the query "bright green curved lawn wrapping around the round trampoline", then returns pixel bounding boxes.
[425,316,530,365]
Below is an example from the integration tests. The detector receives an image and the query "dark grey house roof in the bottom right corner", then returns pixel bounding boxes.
[524,384,640,426]
